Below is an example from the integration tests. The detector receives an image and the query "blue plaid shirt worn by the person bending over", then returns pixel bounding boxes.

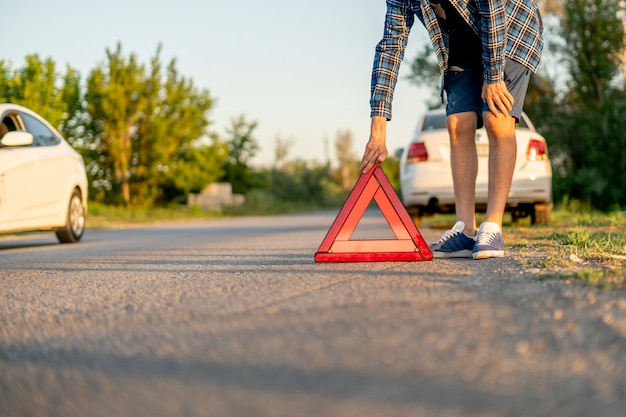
[370,0,543,120]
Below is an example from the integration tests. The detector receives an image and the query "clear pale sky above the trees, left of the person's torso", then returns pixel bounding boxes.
[0,0,427,165]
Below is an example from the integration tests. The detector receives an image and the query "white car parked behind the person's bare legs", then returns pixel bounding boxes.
[400,109,552,225]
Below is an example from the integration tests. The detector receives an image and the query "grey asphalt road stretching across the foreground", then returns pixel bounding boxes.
[0,213,626,417]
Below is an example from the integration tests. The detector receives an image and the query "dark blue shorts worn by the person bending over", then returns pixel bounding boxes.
[443,58,530,127]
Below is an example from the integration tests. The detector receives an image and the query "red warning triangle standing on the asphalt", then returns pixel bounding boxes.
[315,166,433,262]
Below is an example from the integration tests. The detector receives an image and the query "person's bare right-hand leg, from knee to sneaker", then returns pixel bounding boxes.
[483,112,517,229]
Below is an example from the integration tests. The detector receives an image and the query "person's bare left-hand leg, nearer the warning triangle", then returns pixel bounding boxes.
[446,112,478,236]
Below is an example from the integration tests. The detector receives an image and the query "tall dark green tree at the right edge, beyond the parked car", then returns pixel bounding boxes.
[554,0,626,209]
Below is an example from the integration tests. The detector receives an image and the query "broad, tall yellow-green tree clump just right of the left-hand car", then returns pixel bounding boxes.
[85,44,219,206]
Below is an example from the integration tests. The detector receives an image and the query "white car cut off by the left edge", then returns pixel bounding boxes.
[0,104,88,243]
